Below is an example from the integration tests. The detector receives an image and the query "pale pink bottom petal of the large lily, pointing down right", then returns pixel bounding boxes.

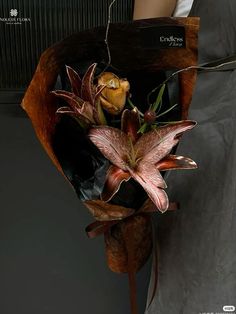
[130,170,169,213]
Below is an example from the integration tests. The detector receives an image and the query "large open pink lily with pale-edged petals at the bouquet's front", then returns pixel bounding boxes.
[89,110,197,212]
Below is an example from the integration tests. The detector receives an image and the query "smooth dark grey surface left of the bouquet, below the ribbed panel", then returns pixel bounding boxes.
[0,104,150,314]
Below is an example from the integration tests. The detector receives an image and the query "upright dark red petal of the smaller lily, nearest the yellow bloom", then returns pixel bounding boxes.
[81,63,97,104]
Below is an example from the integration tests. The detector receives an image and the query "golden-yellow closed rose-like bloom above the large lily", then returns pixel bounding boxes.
[98,72,130,115]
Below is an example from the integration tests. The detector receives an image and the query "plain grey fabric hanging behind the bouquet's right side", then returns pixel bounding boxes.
[146,0,236,314]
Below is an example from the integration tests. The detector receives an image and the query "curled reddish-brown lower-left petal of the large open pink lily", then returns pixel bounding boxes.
[101,166,131,202]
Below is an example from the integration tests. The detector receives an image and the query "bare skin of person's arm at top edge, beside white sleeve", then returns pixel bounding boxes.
[133,0,177,20]
